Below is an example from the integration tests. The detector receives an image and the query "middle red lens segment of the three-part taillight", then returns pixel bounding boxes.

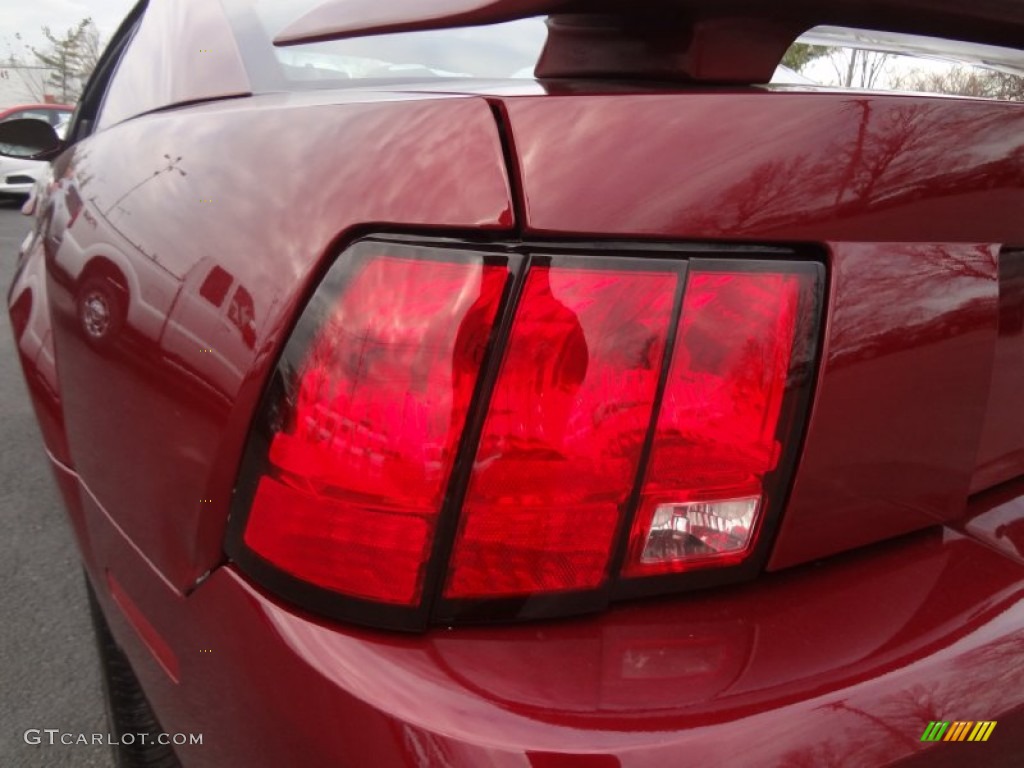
[444,264,677,598]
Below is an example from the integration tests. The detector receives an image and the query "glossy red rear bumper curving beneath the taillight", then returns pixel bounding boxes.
[77,462,1024,767]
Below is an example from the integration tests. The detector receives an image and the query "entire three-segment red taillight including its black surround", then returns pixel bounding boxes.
[228,240,823,629]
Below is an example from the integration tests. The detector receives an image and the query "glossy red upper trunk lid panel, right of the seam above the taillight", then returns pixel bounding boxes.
[503,89,1024,243]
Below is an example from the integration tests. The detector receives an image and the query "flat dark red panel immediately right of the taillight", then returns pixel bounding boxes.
[771,244,995,567]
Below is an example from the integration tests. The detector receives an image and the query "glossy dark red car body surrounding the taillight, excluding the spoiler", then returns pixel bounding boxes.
[9,3,1024,768]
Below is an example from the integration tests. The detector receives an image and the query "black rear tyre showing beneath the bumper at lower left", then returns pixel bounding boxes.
[85,578,180,768]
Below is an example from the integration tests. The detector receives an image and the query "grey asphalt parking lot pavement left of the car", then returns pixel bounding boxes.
[0,203,113,768]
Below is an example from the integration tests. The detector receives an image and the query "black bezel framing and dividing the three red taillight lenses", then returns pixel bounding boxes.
[225,233,827,632]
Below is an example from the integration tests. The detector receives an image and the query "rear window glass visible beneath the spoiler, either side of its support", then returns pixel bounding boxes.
[222,0,1024,100]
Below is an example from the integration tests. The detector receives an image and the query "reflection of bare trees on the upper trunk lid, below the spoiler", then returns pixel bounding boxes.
[689,98,1024,233]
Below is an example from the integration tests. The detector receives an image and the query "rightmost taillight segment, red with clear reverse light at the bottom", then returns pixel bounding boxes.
[623,270,801,577]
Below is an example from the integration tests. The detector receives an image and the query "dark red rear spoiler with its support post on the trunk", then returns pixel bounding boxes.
[273,0,1024,84]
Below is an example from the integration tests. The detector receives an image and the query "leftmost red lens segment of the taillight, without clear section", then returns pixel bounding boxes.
[245,255,508,605]
